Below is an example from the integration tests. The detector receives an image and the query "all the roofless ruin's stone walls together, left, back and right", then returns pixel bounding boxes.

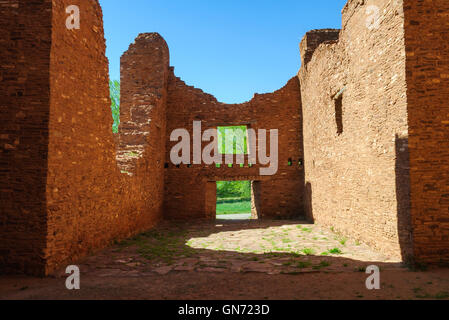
[0,0,449,275]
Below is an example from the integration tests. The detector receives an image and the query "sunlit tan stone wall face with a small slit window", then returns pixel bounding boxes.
[299,0,412,258]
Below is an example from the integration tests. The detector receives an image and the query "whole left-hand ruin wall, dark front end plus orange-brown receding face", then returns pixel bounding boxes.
[0,0,165,275]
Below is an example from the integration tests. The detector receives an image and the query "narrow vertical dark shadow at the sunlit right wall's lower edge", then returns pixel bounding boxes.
[395,135,414,264]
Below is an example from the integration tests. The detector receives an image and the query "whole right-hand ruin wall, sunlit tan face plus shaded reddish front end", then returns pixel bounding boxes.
[298,0,449,265]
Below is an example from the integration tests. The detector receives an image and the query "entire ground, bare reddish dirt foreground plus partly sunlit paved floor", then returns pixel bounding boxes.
[0,221,449,300]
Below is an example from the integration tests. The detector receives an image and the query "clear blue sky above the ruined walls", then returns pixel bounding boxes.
[100,0,346,103]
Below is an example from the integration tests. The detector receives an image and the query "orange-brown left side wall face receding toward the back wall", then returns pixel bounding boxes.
[46,0,164,272]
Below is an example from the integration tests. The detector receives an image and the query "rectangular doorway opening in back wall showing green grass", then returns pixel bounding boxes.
[215,181,259,220]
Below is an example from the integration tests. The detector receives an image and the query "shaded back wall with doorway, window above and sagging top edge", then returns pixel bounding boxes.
[164,73,304,219]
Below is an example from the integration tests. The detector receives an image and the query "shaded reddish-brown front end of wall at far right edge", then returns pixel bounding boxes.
[404,0,449,264]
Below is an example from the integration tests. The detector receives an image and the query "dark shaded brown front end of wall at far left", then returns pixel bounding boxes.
[0,0,51,273]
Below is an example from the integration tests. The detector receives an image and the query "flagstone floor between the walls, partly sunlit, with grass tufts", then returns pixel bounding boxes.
[75,221,400,276]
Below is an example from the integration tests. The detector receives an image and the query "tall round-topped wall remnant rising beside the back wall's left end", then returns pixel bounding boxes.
[118,33,169,175]
